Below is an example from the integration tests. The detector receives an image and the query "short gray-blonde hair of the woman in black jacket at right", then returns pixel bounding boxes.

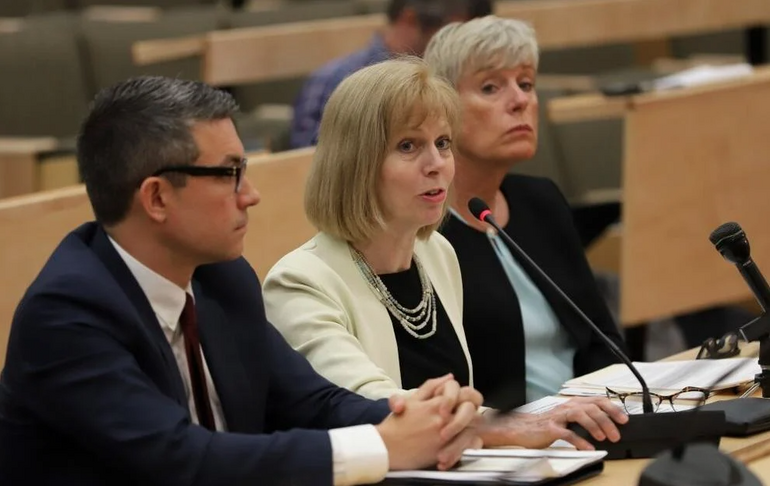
[425,15,539,86]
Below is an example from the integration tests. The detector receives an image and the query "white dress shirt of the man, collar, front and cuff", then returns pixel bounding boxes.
[110,238,388,486]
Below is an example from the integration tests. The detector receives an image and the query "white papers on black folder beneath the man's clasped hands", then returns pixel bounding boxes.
[386,449,607,483]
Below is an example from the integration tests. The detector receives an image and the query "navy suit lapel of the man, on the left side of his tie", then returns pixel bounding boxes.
[91,227,189,410]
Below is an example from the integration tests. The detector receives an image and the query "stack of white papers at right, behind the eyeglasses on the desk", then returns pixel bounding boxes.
[564,358,760,393]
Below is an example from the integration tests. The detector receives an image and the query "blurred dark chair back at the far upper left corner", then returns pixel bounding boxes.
[0,14,90,137]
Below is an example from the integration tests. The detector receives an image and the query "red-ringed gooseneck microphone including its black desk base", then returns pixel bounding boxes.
[468,197,725,460]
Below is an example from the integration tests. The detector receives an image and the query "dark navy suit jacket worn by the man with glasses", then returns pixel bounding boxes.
[0,223,388,485]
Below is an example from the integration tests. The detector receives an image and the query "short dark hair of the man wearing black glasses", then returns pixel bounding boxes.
[77,76,238,226]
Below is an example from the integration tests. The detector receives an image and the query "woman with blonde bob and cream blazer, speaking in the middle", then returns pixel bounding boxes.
[264,57,472,398]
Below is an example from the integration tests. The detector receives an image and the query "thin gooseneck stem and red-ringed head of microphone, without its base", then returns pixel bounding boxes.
[468,197,655,413]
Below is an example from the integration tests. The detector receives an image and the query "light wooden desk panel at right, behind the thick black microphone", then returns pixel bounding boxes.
[549,65,770,327]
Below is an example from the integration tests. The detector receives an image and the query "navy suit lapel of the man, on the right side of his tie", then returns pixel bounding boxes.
[193,281,260,433]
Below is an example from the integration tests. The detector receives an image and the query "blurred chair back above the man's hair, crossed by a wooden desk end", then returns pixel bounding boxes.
[82,7,227,94]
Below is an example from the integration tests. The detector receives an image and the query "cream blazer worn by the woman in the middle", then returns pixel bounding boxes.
[264,233,473,398]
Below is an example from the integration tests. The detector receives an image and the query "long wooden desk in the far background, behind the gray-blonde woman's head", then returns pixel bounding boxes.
[133,0,770,85]
